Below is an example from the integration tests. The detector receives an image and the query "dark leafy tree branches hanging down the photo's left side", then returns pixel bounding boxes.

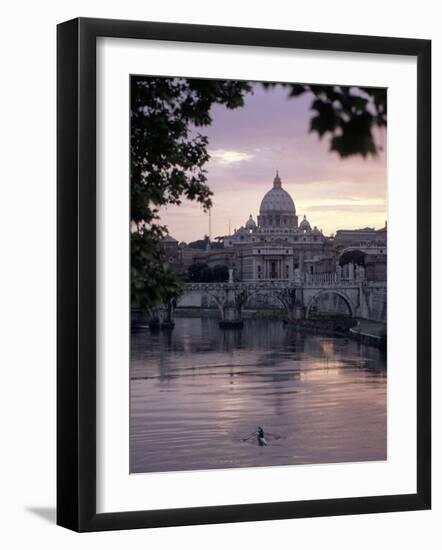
[130,76,251,310]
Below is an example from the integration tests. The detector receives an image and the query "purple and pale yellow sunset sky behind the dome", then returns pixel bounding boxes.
[161,84,387,242]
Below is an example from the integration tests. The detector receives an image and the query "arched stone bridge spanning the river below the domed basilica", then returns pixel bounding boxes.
[178,273,386,326]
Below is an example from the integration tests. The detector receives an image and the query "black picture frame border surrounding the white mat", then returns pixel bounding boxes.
[57,18,431,531]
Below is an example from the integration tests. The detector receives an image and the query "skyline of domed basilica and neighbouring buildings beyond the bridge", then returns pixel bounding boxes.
[165,172,387,282]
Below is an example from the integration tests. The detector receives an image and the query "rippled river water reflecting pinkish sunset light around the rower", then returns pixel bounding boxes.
[130,318,387,472]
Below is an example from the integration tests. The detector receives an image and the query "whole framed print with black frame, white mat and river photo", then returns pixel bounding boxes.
[57,18,431,531]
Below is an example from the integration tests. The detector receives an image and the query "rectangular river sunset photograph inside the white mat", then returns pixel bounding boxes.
[128,75,388,474]
